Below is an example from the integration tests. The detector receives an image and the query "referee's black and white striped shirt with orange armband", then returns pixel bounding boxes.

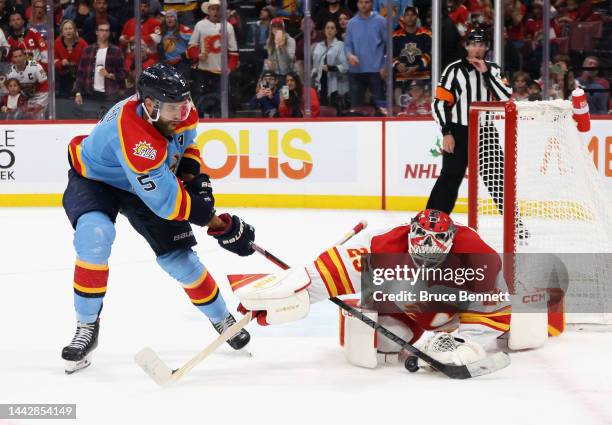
[432,59,512,134]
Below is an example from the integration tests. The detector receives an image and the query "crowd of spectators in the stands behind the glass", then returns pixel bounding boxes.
[0,0,612,119]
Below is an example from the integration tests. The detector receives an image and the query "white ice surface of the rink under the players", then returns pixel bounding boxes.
[0,208,612,425]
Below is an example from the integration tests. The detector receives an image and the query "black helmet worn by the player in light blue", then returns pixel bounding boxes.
[138,63,191,102]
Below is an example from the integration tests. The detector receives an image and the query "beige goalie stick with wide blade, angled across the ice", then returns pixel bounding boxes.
[134,311,253,387]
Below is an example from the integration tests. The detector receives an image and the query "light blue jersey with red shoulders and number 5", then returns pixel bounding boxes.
[69,97,201,220]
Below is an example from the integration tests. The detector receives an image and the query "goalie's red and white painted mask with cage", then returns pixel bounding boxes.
[408,210,457,267]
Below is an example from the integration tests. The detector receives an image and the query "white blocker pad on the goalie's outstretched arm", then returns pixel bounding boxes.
[234,267,311,325]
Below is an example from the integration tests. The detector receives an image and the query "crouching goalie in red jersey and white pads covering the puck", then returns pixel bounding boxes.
[232,210,510,367]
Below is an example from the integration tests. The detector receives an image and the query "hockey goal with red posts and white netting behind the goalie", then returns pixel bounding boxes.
[468,101,612,324]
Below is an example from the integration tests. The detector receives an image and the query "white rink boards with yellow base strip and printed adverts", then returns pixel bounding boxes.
[0,118,612,212]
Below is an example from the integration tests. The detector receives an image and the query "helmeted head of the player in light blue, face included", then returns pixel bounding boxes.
[137,63,193,122]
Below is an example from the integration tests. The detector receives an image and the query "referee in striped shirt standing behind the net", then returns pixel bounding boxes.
[427,28,512,214]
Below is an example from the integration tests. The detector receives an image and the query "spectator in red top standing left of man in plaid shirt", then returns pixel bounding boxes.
[54,19,87,97]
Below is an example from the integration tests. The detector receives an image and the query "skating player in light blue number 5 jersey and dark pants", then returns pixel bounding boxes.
[62,64,255,373]
